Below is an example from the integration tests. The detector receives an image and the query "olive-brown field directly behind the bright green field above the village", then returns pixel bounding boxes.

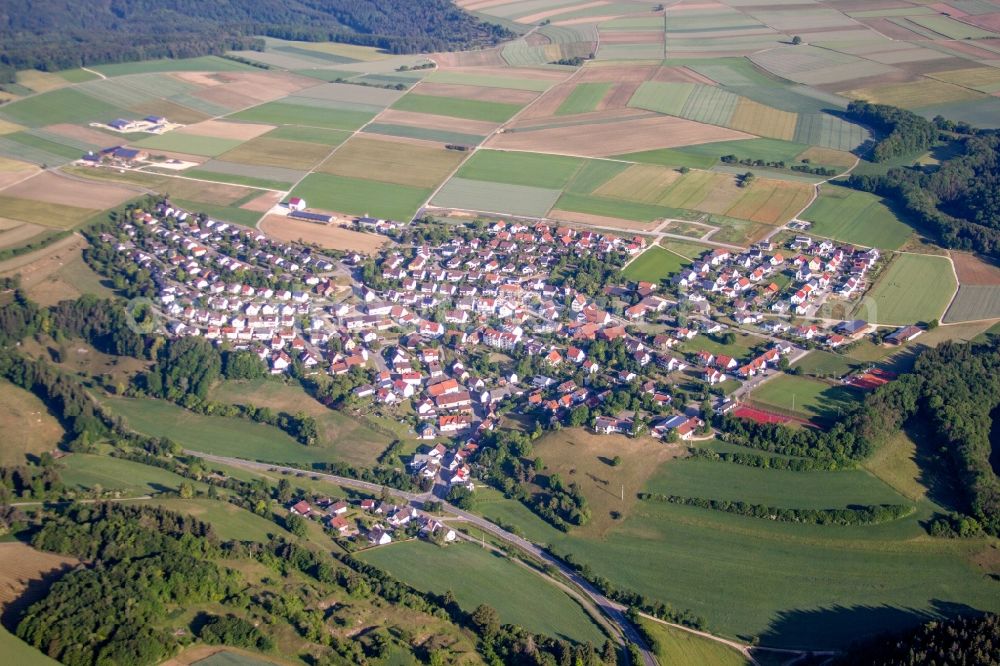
[318,136,467,188]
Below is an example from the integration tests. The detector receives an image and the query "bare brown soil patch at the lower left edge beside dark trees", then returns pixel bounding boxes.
[0,541,79,613]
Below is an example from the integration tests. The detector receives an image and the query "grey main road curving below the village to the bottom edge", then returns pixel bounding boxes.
[184,449,657,666]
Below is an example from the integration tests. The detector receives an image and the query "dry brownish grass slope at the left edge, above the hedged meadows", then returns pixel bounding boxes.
[0,380,63,466]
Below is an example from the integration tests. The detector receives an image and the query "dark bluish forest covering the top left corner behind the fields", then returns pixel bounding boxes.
[0,0,510,83]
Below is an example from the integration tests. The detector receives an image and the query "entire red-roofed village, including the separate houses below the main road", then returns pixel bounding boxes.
[95,201,922,545]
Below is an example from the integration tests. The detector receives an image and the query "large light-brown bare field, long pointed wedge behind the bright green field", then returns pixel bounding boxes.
[486,116,752,157]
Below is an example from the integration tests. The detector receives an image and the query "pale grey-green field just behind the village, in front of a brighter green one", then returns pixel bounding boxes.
[431,177,559,217]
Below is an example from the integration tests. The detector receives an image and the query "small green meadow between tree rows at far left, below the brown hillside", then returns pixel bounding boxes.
[59,453,204,497]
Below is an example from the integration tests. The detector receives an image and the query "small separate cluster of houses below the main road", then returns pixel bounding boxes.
[288,497,457,546]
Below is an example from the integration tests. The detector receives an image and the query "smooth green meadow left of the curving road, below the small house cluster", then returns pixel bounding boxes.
[361,541,605,645]
